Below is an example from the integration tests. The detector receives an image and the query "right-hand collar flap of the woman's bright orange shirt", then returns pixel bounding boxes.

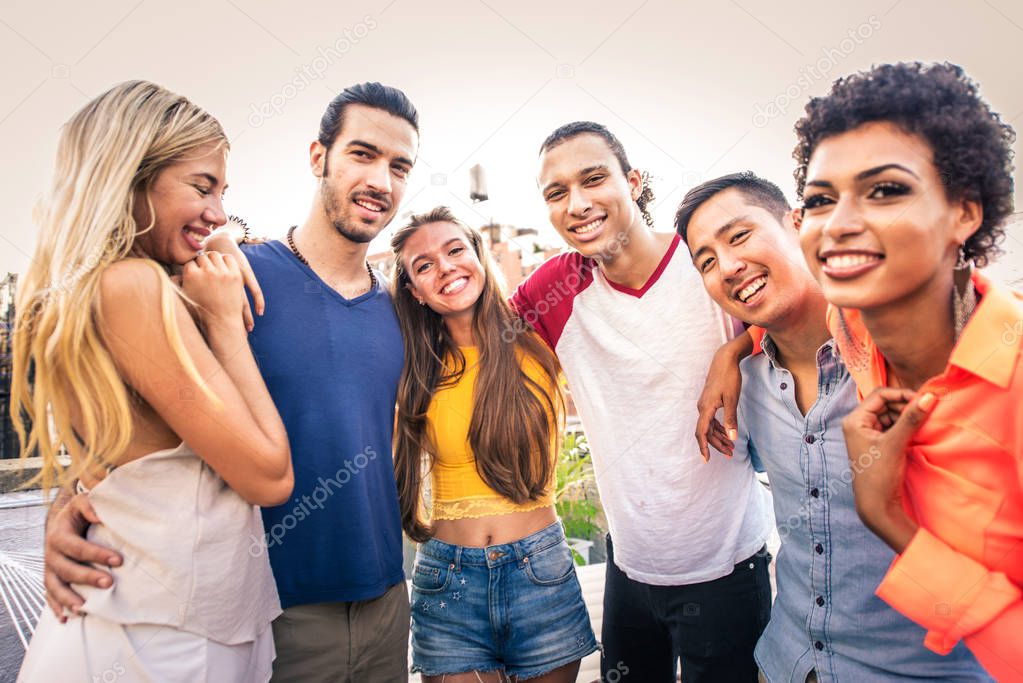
[948,271,1023,389]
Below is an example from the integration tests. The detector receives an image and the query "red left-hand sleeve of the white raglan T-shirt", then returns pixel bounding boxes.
[510,252,595,350]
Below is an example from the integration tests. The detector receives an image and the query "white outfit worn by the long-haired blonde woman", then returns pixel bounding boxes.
[17,444,280,683]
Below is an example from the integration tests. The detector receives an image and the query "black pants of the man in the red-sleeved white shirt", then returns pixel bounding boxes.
[601,536,771,683]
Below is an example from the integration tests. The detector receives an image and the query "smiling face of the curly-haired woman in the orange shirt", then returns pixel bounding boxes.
[800,122,981,310]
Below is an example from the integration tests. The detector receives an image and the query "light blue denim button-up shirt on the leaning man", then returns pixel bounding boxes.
[736,336,991,683]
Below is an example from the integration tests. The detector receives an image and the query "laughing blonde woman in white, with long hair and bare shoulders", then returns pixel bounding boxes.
[11,81,293,681]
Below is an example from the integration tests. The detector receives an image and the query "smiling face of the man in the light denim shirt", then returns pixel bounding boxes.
[686,187,819,331]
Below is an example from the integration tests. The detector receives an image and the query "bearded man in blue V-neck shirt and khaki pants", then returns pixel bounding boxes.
[47,83,418,683]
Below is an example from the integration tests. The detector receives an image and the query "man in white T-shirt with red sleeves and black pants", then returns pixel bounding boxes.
[513,122,771,683]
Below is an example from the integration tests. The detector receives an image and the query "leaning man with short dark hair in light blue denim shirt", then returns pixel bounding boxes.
[675,172,988,682]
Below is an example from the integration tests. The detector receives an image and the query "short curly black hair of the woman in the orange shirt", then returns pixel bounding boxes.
[792,61,1016,267]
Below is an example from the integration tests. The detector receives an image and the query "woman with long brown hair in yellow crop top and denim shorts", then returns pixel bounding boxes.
[391,207,596,683]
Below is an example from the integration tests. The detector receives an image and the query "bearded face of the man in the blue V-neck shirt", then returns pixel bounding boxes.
[310,104,418,243]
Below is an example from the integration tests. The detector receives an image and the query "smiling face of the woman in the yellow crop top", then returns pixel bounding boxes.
[401,222,486,318]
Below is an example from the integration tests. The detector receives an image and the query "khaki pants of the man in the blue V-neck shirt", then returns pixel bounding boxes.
[271,581,410,683]
